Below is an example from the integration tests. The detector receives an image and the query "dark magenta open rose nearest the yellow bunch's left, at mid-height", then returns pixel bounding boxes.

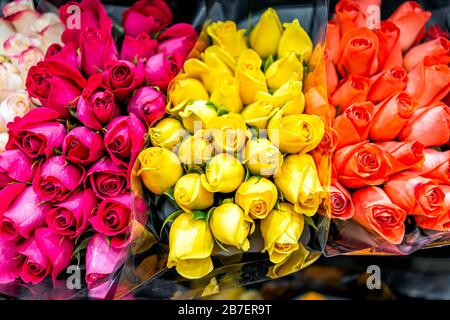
[86,157,129,199]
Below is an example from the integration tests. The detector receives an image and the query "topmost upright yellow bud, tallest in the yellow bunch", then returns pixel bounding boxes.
[249,8,283,59]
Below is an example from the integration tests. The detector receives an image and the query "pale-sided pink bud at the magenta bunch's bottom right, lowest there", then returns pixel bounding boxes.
[86,233,127,289]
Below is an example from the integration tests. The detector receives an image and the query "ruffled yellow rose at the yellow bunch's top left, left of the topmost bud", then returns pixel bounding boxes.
[206,21,247,57]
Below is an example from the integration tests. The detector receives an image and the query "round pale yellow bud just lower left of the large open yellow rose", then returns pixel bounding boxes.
[244,138,283,177]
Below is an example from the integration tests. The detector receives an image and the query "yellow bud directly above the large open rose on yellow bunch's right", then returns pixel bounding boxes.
[273,79,305,116]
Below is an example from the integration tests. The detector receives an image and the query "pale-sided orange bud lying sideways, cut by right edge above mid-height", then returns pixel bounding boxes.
[398,102,450,147]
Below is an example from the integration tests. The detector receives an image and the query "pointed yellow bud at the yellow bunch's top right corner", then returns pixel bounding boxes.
[278,19,313,61]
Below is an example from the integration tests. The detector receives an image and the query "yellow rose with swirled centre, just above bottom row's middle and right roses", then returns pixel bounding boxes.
[235,177,278,219]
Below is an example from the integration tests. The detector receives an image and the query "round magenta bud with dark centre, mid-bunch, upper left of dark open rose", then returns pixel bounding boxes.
[62,127,105,166]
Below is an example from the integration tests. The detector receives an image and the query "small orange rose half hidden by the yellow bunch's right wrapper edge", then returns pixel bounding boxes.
[330,180,355,220]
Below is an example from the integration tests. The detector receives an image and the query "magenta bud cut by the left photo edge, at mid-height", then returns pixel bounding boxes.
[0,149,36,188]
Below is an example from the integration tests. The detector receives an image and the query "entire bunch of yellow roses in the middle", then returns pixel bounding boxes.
[137,9,324,279]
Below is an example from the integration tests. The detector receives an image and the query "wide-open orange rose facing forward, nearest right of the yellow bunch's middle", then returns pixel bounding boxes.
[333,141,392,188]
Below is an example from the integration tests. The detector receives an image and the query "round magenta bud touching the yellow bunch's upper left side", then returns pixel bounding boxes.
[127,87,166,126]
